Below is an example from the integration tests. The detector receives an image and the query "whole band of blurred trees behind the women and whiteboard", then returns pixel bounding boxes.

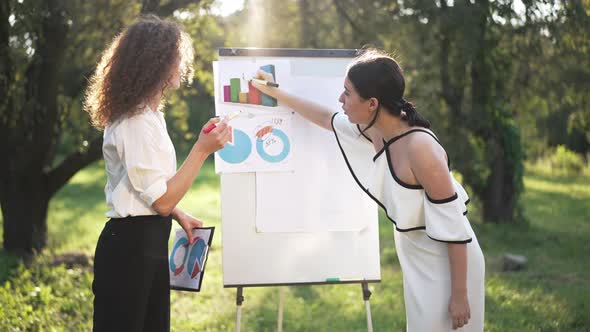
[0,0,590,253]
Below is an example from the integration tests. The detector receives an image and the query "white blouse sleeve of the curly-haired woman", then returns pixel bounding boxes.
[117,114,168,206]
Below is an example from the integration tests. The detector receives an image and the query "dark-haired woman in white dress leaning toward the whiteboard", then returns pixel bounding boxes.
[254,50,485,332]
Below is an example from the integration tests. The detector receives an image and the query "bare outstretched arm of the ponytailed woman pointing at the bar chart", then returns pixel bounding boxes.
[252,70,334,131]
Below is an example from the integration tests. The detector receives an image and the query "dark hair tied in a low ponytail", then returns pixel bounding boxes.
[347,49,430,130]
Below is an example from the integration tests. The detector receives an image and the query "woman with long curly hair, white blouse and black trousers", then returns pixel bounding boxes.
[85,15,230,331]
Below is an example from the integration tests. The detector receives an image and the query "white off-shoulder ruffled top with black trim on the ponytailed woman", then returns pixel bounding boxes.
[332,113,471,243]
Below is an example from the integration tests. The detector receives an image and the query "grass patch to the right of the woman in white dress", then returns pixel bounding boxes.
[476,167,590,331]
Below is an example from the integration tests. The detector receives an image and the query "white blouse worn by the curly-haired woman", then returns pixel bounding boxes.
[102,106,176,218]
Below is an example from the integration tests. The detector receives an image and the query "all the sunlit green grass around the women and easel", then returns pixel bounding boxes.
[0,163,590,332]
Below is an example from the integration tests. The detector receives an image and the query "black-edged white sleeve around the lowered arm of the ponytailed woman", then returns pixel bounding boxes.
[424,192,471,243]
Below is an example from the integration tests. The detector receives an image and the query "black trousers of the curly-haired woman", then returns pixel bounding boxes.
[92,216,171,332]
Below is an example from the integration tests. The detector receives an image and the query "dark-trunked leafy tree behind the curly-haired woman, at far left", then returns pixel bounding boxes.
[0,0,215,254]
